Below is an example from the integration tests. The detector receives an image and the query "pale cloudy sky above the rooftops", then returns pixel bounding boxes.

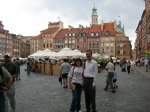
[0,0,145,48]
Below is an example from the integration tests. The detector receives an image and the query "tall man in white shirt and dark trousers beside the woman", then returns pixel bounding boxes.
[83,50,98,112]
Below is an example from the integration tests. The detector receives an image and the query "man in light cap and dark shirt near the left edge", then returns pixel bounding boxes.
[2,53,17,112]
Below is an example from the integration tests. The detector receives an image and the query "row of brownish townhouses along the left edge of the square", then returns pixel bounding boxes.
[0,21,31,58]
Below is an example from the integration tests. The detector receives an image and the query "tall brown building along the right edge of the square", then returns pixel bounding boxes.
[135,0,150,59]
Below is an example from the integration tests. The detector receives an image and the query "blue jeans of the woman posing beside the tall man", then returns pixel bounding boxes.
[70,85,82,112]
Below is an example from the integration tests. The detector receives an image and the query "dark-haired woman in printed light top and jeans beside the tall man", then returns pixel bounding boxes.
[68,58,83,112]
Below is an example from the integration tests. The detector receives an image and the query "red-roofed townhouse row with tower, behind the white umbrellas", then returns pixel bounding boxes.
[32,7,132,59]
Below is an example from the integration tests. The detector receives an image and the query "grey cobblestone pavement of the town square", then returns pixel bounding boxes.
[11,66,150,112]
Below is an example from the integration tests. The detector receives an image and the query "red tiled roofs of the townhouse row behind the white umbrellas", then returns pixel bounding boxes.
[41,22,116,38]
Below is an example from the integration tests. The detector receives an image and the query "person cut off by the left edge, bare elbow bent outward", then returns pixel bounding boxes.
[0,67,13,112]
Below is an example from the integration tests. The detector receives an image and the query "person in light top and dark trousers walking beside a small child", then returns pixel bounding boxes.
[104,58,115,93]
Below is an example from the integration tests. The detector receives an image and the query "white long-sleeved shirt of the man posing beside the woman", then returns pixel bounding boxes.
[84,59,98,85]
